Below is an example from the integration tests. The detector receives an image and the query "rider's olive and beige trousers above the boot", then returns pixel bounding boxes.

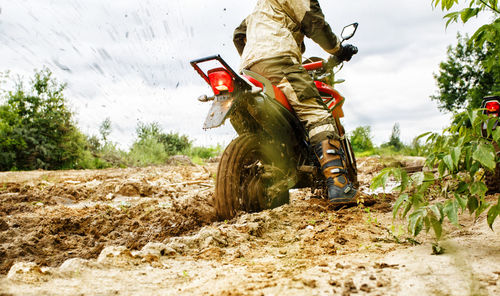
[249,57,339,144]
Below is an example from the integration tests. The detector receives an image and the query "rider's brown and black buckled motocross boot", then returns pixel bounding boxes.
[314,139,359,205]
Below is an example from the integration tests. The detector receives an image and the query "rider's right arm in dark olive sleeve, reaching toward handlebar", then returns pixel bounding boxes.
[300,0,340,54]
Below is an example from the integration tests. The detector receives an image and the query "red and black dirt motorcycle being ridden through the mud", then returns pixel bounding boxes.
[190,23,358,220]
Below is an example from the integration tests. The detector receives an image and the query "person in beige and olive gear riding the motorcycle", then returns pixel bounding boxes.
[233,0,359,204]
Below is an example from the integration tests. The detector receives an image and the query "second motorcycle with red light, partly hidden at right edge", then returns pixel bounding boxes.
[481,96,500,193]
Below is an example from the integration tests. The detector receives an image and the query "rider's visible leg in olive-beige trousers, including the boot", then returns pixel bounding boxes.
[250,57,357,203]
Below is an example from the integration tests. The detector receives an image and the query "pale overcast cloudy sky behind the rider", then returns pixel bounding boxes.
[0,0,492,148]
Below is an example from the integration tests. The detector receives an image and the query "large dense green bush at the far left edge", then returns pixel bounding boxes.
[0,68,85,170]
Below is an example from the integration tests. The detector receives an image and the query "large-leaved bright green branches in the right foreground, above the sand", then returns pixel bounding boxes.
[371,110,500,240]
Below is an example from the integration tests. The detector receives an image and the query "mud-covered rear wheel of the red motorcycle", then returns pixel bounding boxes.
[215,134,289,220]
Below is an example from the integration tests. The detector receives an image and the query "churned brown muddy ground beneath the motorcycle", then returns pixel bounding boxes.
[0,157,500,295]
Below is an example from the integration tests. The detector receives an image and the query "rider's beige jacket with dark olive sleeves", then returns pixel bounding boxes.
[233,0,340,69]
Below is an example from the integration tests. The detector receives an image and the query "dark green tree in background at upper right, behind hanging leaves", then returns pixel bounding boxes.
[431,35,500,112]
